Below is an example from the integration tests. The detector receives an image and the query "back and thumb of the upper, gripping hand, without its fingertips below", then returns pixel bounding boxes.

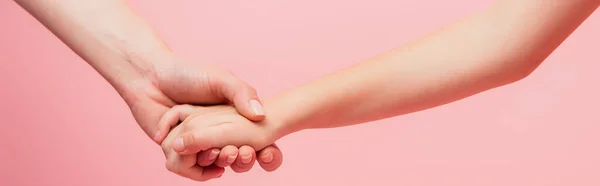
[123,57,265,143]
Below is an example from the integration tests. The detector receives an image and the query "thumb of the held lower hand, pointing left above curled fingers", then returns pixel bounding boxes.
[172,127,229,155]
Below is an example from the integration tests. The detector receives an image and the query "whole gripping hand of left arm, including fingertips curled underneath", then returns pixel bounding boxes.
[122,58,283,181]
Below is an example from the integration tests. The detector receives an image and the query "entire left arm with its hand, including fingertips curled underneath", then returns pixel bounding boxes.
[15,0,282,181]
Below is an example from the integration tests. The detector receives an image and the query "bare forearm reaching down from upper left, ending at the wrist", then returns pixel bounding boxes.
[15,0,171,102]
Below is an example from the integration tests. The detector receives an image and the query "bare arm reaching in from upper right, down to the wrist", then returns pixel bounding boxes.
[265,0,599,137]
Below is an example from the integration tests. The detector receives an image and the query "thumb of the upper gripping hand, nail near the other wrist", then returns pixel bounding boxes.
[216,74,265,121]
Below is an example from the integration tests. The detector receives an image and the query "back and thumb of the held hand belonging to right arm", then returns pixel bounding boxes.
[173,105,276,155]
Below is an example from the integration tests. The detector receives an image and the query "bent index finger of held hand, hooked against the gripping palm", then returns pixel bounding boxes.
[154,105,193,144]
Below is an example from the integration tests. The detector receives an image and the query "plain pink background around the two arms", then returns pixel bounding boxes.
[0,0,600,186]
